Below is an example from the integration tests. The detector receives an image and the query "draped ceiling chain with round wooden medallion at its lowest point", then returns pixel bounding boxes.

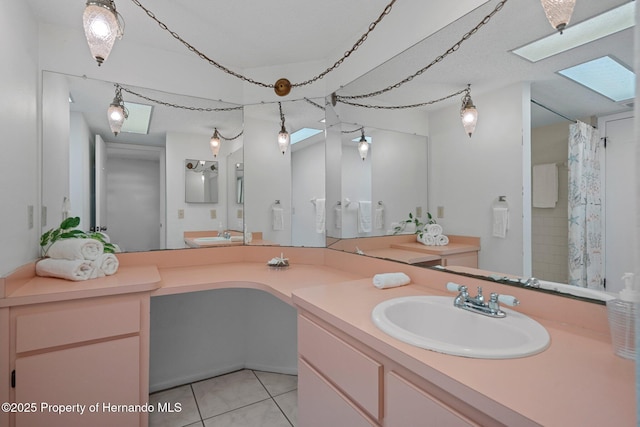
[131,0,396,96]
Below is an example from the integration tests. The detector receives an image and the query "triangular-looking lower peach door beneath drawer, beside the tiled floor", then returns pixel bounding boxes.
[298,359,376,427]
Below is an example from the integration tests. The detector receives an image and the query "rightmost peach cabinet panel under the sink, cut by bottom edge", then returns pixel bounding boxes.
[385,372,478,427]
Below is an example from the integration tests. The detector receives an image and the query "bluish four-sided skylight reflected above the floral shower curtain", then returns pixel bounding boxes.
[558,56,636,102]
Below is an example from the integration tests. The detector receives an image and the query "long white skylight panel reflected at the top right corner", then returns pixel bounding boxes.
[512,1,636,62]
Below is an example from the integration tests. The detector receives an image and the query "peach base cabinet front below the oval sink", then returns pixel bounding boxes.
[298,310,512,427]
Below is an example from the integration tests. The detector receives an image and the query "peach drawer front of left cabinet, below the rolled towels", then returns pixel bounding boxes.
[16,299,140,353]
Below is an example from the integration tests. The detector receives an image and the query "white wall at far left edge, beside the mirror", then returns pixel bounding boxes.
[0,0,39,276]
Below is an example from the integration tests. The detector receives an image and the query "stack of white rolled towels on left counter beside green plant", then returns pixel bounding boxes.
[36,239,120,281]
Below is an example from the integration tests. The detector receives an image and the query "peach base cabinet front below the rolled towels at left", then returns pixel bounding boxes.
[9,295,149,427]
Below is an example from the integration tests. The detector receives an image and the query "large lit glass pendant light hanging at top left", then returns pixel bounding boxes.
[82,0,124,66]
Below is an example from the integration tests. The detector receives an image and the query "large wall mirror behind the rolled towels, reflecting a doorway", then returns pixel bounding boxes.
[42,71,243,251]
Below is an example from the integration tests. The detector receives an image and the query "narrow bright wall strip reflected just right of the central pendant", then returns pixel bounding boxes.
[291,142,326,246]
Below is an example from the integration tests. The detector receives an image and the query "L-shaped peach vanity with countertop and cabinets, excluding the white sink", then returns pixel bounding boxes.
[0,246,635,427]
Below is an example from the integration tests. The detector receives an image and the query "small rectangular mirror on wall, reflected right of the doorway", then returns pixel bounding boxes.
[184,159,219,203]
